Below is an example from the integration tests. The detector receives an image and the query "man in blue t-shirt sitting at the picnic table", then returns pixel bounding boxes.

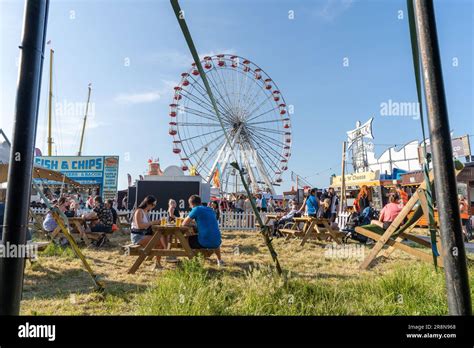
[183,195,223,266]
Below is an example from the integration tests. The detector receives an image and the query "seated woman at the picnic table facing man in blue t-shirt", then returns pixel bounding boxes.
[130,195,168,270]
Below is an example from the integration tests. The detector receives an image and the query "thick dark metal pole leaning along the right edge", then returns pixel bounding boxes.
[415,0,472,315]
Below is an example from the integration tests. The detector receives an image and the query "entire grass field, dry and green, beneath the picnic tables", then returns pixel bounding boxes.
[21,231,474,315]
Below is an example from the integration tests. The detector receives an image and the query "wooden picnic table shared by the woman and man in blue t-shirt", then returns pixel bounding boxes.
[125,225,211,274]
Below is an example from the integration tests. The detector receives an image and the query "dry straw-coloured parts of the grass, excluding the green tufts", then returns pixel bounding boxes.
[21,231,473,315]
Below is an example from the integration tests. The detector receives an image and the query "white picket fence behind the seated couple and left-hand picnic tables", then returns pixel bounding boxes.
[32,208,265,230]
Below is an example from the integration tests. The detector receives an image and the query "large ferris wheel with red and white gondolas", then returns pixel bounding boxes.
[169,54,292,193]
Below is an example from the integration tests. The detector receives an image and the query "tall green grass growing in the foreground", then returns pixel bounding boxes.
[136,259,456,315]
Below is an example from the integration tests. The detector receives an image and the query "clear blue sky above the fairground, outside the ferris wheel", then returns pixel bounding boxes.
[0,0,474,189]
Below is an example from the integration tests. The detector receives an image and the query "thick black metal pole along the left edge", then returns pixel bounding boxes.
[0,0,49,315]
